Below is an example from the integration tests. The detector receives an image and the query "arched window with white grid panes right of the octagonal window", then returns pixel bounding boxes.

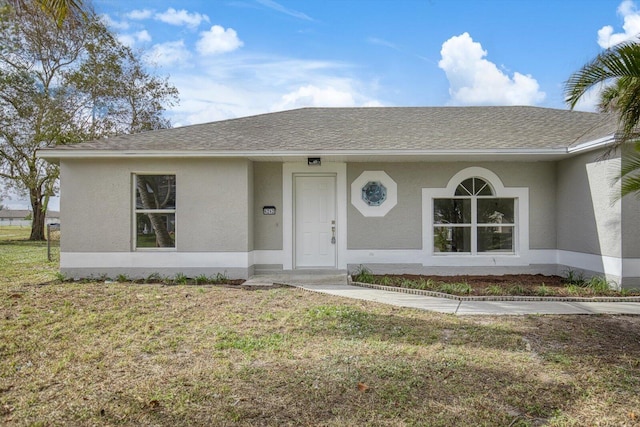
[433,177,516,255]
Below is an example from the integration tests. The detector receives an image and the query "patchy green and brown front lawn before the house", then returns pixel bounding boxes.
[0,226,640,426]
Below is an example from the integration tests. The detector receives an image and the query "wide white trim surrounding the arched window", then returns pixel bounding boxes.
[422,166,529,266]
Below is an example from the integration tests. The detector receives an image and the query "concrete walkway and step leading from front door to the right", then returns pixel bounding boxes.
[245,273,640,315]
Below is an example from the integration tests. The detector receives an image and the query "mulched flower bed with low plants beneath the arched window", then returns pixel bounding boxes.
[352,269,640,297]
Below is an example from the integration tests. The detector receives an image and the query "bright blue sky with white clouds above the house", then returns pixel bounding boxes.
[4,0,640,209]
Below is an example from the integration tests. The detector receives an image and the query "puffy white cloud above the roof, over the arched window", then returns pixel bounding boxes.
[438,33,545,105]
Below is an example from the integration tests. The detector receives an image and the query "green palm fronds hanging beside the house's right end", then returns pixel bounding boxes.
[565,41,640,196]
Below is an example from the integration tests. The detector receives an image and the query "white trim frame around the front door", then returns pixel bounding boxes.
[282,162,347,270]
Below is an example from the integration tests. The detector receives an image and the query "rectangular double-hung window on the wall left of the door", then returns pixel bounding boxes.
[133,175,176,249]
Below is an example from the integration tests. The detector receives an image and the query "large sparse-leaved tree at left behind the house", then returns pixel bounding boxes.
[0,1,177,240]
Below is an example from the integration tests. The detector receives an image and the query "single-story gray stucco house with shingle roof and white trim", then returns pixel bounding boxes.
[39,107,640,286]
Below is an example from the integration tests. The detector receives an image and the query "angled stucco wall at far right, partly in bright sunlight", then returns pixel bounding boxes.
[557,151,622,257]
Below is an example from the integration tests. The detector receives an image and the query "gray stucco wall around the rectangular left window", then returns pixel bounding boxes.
[60,159,253,252]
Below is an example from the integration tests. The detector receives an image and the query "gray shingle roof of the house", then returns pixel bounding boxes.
[40,106,616,152]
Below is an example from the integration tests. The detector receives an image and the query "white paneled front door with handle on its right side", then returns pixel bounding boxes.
[294,175,337,268]
